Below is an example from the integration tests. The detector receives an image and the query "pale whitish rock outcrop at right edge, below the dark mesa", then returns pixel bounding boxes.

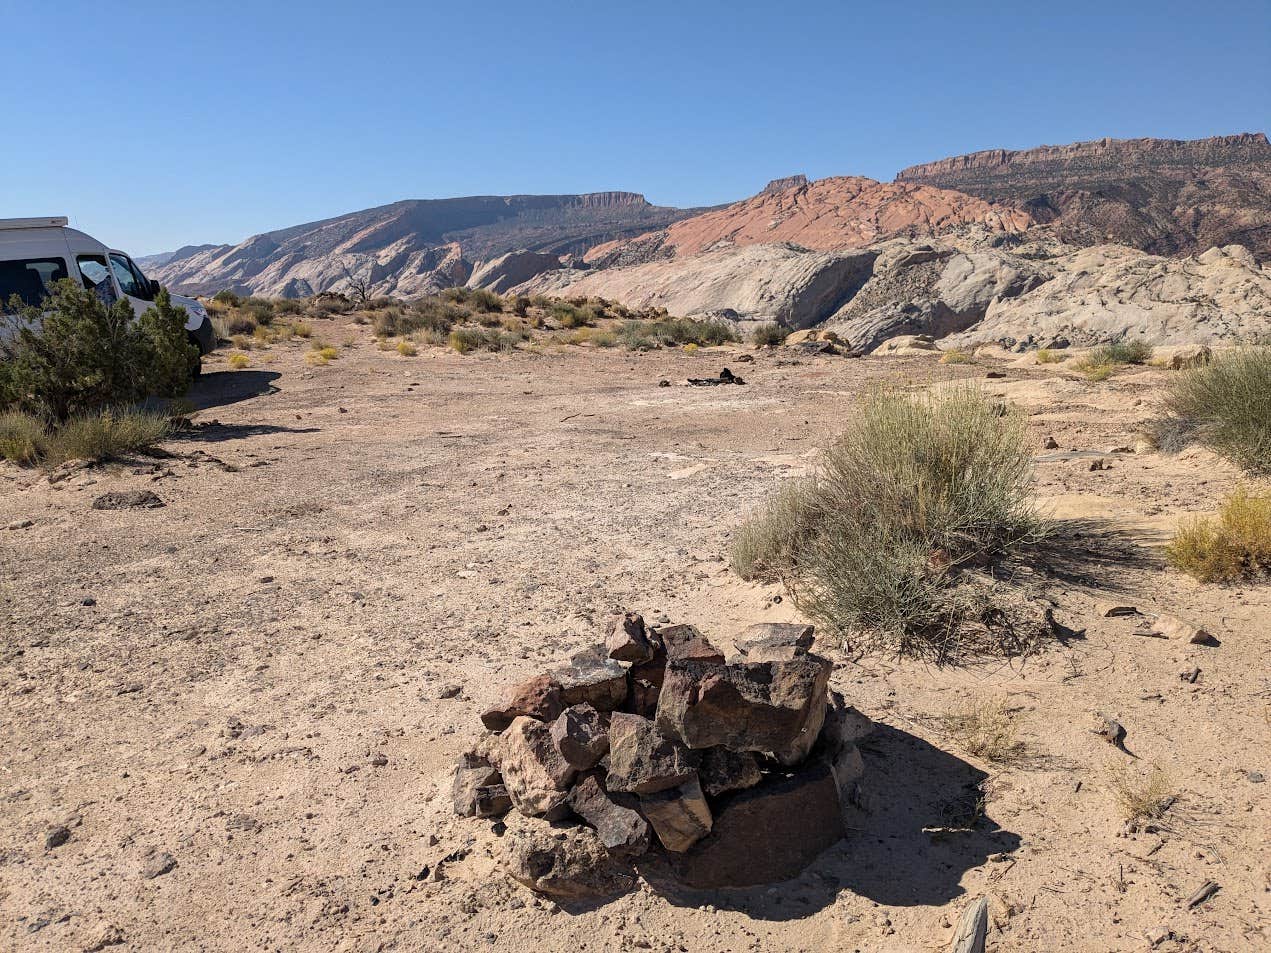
[949,245,1271,348]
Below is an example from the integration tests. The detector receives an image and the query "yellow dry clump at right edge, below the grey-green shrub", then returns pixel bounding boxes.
[1166,487,1271,582]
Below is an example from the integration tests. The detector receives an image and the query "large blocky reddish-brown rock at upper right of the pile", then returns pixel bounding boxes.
[657,654,833,755]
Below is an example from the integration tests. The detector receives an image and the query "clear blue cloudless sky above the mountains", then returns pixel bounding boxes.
[0,0,1271,254]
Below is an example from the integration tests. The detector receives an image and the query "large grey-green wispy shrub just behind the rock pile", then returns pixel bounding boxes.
[732,389,1046,658]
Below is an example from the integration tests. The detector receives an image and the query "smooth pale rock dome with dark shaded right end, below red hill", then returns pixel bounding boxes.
[517,245,874,328]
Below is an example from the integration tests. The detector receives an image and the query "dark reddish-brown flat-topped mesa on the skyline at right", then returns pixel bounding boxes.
[896,132,1271,260]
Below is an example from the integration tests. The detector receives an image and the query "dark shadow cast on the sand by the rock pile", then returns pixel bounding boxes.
[641,724,1019,920]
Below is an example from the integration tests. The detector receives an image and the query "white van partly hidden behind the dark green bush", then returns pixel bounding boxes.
[0,216,216,368]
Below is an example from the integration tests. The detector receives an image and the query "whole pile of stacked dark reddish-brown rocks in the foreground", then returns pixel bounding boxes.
[454,612,872,896]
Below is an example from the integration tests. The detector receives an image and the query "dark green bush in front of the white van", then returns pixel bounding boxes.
[0,281,198,422]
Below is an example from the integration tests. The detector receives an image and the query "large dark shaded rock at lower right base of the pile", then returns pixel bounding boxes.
[676,759,846,889]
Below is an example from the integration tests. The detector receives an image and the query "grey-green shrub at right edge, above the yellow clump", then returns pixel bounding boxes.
[1152,344,1271,474]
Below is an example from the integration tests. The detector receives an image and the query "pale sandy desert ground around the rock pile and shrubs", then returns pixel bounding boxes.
[0,323,1271,953]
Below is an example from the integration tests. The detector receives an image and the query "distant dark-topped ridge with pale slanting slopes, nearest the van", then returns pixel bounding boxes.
[151,192,699,297]
